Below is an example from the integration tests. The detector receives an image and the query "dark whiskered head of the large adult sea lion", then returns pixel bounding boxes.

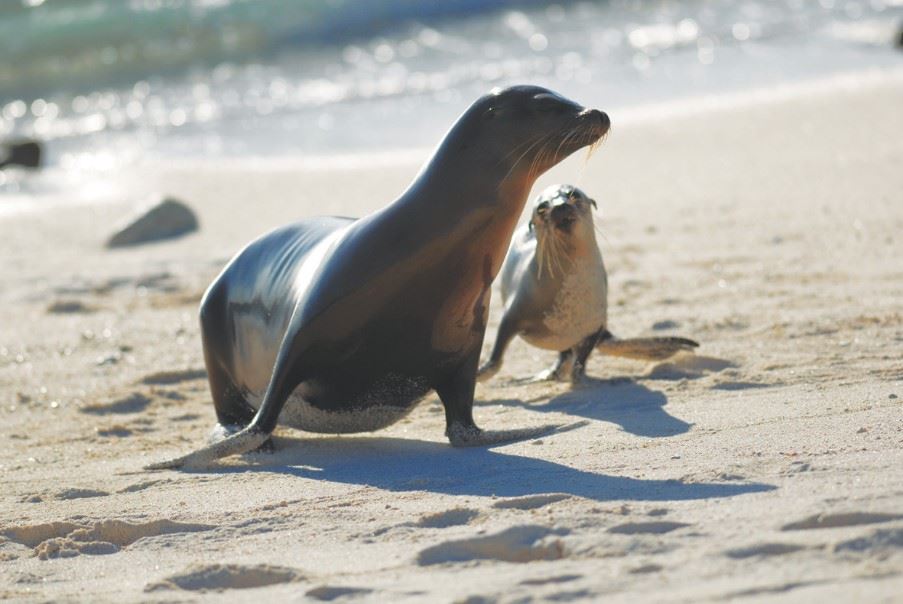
[447,86,611,184]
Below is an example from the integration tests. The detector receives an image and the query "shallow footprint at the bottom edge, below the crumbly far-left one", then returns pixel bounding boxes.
[144,564,304,592]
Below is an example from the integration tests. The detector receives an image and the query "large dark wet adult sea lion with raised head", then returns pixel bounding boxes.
[149,86,609,469]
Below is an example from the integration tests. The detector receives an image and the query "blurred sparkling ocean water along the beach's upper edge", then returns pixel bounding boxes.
[0,0,903,196]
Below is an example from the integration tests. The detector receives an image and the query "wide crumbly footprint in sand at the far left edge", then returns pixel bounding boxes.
[0,520,216,560]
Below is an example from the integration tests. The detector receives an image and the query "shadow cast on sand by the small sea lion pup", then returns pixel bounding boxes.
[485,377,693,437]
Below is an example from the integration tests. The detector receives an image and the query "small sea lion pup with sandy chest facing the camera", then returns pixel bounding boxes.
[477,185,699,382]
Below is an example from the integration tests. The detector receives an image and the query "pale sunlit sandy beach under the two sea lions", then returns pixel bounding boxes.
[0,72,903,602]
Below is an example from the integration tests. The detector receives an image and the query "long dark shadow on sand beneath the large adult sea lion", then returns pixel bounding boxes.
[217,436,776,501]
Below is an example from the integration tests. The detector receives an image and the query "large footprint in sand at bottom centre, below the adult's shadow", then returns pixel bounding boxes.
[417,525,568,566]
